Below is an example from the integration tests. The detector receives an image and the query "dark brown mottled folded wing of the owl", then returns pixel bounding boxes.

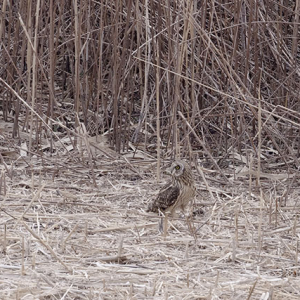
[147,184,180,212]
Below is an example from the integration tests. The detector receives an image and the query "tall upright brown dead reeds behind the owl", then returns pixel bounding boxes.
[0,0,300,166]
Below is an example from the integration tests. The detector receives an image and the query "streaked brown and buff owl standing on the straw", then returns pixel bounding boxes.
[148,160,196,216]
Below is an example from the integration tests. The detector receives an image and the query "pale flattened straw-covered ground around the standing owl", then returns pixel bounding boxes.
[0,122,300,299]
